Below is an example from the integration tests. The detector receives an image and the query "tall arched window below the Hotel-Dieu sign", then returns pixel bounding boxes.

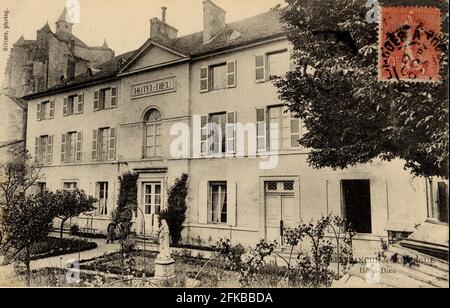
[144,109,162,158]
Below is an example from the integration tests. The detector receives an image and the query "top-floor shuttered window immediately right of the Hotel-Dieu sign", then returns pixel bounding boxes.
[200,61,237,92]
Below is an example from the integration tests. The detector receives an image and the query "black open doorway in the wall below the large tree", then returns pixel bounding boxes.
[341,180,372,233]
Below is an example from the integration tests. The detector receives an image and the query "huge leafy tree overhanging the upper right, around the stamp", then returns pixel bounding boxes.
[273,0,449,178]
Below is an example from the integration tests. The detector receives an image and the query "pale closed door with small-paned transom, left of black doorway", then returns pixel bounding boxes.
[264,181,300,244]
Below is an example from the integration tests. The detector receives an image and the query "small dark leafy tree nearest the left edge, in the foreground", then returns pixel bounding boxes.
[1,193,54,284]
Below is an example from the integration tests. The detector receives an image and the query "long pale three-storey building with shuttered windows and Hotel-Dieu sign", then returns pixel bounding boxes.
[26,1,446,250]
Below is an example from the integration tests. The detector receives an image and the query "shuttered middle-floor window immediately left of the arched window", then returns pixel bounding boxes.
[92,127,116,161]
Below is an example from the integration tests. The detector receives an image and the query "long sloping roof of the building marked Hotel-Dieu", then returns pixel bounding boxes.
[23,10,285,98]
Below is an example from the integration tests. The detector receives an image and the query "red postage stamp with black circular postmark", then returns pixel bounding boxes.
[379,7,442,82]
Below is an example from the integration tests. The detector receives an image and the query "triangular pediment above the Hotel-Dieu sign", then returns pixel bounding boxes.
[120,41,188,73]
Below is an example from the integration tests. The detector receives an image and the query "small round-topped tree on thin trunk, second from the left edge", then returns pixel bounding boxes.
[53,189,98,248]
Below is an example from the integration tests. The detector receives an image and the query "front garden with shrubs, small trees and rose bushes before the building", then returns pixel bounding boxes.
[0,158,354,288]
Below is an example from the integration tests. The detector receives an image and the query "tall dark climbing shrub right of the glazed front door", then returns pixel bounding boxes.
[160,173,189,245]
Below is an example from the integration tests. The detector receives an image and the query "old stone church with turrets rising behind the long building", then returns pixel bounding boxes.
[0,9,114,162]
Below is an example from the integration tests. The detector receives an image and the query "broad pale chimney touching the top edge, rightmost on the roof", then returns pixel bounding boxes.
[203,0,226,44]
